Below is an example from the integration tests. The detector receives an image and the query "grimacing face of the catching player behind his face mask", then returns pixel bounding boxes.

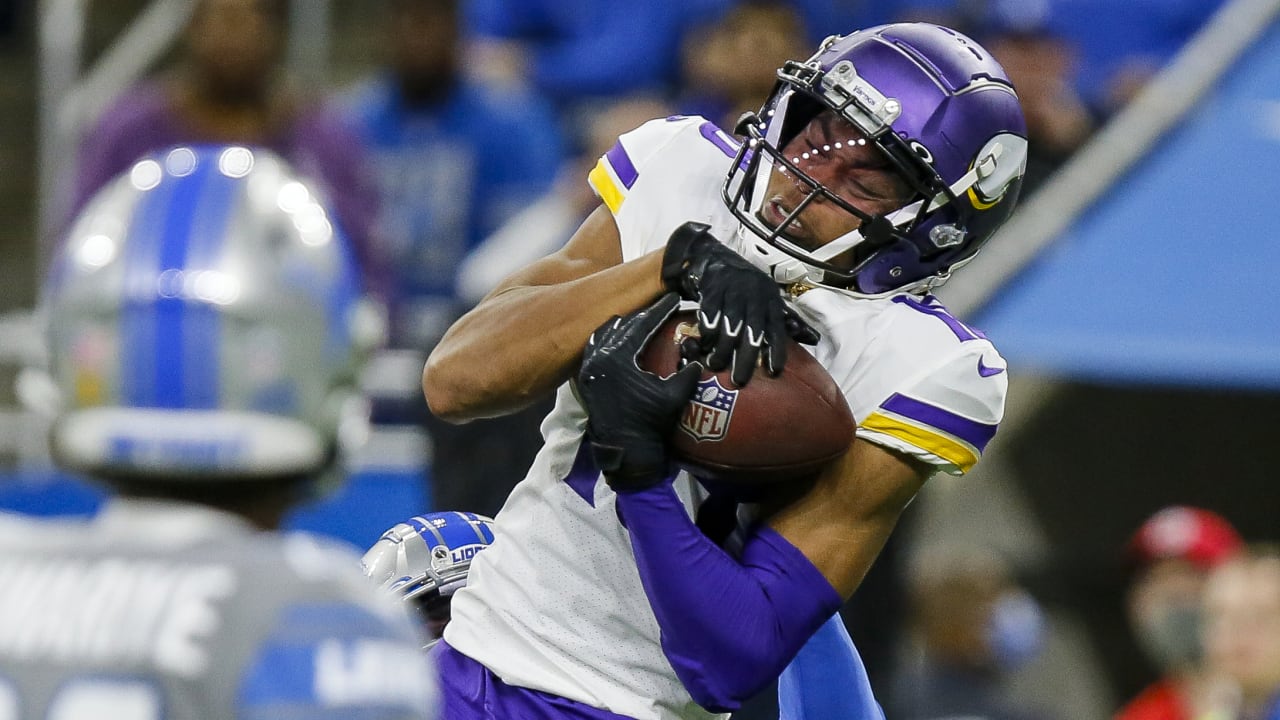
[759,110,910,265]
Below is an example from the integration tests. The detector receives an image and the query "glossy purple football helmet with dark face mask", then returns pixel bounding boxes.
[724,23,1027,295]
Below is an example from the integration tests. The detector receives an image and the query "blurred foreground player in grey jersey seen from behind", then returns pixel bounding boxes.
[0,146,436,720]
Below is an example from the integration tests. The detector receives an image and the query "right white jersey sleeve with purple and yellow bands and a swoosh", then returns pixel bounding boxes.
[858,296,1009,474]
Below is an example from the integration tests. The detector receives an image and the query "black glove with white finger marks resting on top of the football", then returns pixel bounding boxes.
[662,222,820,386]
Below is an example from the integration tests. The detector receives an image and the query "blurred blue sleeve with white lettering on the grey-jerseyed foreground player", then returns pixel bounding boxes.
[237,602,435,720]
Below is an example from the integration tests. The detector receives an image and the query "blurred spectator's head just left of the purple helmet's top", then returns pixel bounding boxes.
[678,0,809,132]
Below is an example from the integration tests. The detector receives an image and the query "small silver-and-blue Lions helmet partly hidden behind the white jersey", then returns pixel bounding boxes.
[361,511,494,639]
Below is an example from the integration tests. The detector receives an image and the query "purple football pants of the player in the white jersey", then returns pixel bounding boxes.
[431,639,631,720]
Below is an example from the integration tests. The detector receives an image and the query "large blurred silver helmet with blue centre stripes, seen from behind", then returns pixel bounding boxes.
[37,146,381,482]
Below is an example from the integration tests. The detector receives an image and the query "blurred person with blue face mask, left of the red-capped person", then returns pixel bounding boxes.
[886,548,1048,720]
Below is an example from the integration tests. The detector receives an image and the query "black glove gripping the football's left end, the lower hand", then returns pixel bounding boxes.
[577,293,703,492]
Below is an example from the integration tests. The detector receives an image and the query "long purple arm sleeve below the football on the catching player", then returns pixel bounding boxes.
[618,483,842,712]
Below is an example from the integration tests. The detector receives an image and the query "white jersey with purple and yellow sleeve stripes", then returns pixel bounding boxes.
[444,117,1006,720]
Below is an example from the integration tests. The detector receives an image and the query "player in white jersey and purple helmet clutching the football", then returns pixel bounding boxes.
[422,23,1027,720]
